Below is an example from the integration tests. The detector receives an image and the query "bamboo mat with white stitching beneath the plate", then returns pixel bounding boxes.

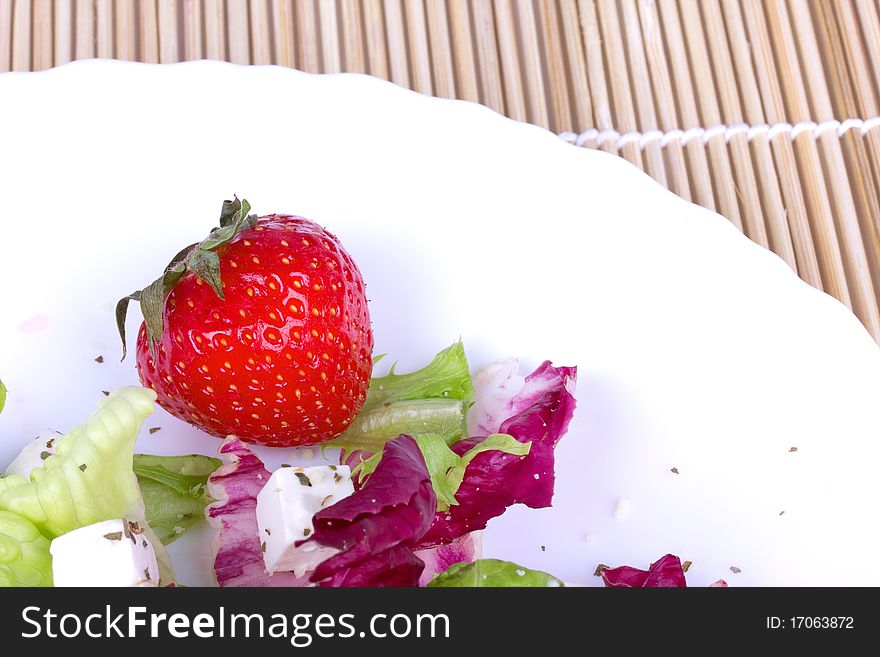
[0,0,880,341]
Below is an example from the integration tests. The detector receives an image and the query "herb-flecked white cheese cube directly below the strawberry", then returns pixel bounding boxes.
[257,465,354,577]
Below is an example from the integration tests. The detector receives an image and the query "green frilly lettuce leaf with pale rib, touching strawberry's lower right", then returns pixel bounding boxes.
[322,341,474,452]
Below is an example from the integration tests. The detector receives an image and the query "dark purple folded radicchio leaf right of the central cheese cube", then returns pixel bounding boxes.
[299,435,437,586]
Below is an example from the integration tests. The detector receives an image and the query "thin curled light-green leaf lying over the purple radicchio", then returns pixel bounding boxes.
[352,433,532,511]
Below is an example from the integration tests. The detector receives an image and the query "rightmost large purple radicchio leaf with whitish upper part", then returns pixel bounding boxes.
[419,361,577,548]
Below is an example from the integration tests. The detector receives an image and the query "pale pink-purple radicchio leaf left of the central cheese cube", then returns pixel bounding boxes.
[205,437,309,587]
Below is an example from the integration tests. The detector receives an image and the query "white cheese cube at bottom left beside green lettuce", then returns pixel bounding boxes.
[49,519,159,587]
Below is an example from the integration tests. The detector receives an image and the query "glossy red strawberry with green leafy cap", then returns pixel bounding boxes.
[116,198,373,447]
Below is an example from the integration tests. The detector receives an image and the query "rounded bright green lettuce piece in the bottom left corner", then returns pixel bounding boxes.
[0,511,52,587]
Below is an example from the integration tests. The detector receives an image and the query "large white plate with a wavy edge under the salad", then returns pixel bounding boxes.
[0,61,880,586]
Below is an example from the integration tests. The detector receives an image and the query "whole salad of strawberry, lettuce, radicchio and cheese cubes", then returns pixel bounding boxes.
[0,198,686,587]
